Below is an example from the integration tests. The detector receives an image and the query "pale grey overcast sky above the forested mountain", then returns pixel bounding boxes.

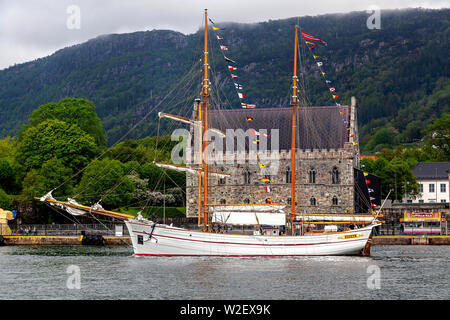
[0,0,450,69]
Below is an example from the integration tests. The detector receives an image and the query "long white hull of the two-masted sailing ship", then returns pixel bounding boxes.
[125,219,377,257]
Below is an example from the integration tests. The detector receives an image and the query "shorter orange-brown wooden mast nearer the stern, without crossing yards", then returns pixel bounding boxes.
[291,26,298,234]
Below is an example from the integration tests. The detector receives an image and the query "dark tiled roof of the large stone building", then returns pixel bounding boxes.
[209,106,350,150]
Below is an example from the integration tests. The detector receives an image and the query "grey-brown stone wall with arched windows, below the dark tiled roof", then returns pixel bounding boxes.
[186,143,354,217]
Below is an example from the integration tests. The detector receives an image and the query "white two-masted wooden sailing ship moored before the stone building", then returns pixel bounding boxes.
[40,9,380,257]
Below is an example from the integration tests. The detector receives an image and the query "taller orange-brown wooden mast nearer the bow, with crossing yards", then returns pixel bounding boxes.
[202,9,209,230]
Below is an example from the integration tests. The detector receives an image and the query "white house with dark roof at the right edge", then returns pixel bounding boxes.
[403,162,450,203]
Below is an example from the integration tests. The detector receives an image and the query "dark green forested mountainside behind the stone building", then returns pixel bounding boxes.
[0,9,450,152]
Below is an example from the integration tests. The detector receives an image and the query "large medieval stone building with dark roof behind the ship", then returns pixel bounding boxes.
[186,98,372,217]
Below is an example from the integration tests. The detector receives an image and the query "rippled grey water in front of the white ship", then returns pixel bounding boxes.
[0,246,450,300]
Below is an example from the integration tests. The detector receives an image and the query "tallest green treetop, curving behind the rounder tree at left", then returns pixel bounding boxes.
[30,98,106,147]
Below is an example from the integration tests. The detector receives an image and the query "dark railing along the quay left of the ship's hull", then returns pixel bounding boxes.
[11,223,129,237]
